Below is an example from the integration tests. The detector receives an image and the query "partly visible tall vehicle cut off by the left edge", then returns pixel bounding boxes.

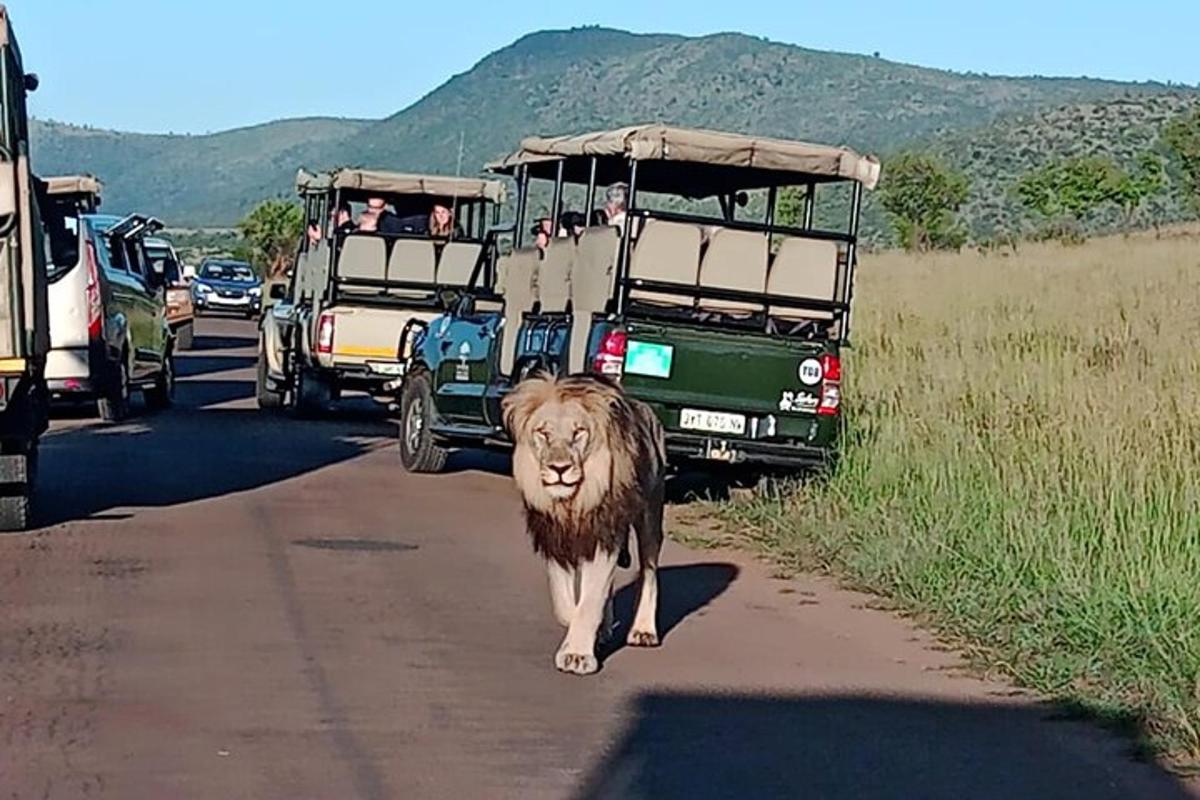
[0,5,50,530]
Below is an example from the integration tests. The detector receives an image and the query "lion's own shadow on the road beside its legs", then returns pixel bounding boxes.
[600,559,740,661]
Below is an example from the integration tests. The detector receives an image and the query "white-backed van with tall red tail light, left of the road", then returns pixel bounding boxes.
[46,175,175,422]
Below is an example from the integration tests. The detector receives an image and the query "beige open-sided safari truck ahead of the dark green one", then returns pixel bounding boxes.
[257,169,505,413]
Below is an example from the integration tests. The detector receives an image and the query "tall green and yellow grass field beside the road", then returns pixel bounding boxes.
[700,231,1200,765]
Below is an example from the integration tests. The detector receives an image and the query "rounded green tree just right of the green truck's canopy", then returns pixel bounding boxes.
[880,152,970,251]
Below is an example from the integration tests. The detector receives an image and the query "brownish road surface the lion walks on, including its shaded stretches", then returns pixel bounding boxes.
[0,320,1192,800]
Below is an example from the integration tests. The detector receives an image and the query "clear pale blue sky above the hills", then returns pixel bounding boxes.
[16,0,1200,133]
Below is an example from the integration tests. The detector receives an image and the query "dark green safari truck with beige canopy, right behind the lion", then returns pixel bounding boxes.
[400,126,880,471]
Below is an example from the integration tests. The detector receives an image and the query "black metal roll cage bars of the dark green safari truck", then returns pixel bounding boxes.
[501,156,863,343]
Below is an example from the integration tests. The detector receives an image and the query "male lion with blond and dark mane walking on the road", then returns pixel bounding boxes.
[503,375,666,675]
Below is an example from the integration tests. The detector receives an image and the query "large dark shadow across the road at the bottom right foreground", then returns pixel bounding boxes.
[574,692,1190,800]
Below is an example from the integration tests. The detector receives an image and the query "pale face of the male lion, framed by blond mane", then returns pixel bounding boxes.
[504,378,618,512]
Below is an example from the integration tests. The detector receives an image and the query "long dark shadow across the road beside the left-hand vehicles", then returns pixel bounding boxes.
[36,321,398,525]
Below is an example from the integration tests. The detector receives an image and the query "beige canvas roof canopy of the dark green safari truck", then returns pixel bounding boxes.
[487,125,880,197]
